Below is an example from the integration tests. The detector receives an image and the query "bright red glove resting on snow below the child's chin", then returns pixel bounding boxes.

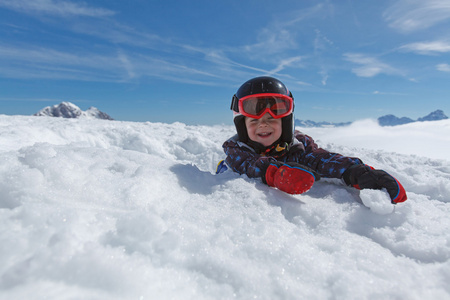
[263,161,320,194]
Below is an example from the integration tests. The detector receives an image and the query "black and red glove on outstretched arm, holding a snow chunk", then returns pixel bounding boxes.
[342,165,408,204]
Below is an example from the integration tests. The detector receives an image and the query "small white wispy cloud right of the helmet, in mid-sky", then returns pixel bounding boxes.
[344,53,402,77]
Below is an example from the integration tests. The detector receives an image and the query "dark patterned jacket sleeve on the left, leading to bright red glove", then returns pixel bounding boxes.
[222,138,275,178]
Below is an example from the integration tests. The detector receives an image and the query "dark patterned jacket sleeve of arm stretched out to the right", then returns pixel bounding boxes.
[290,131,363,178]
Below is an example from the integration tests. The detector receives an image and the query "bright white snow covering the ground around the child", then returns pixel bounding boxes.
[0,115,450,299]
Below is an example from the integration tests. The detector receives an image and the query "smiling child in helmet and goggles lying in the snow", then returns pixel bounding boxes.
[223,77,407,203]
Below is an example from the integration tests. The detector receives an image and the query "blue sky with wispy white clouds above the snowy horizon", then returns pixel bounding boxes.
[0,0,450,125]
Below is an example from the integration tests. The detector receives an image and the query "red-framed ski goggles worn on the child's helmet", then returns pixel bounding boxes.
[238,93,294,119]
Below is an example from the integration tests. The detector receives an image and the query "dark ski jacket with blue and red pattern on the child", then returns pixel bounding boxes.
[223,130,363,178]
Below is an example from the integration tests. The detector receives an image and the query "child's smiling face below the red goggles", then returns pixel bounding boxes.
[245,113,282,147]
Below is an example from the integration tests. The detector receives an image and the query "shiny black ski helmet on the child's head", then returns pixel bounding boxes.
[231,76,294,144]
